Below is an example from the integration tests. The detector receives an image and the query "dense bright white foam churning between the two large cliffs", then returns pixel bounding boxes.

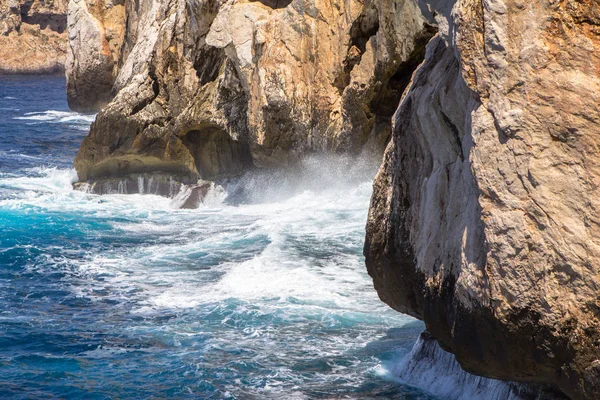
[0,158,404,316]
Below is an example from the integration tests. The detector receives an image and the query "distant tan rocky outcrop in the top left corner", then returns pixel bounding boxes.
[0,0,67,74]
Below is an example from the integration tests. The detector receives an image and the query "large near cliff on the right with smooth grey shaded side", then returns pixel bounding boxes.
[365,0,600,399]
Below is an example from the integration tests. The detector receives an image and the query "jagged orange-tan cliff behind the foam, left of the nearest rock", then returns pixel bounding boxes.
[67,0,434,191]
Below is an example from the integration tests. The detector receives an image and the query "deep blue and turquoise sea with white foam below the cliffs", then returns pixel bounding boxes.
[0,77,433,399]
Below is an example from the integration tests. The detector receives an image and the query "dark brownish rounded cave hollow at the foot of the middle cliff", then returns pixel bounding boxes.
[183,125,252,180]
